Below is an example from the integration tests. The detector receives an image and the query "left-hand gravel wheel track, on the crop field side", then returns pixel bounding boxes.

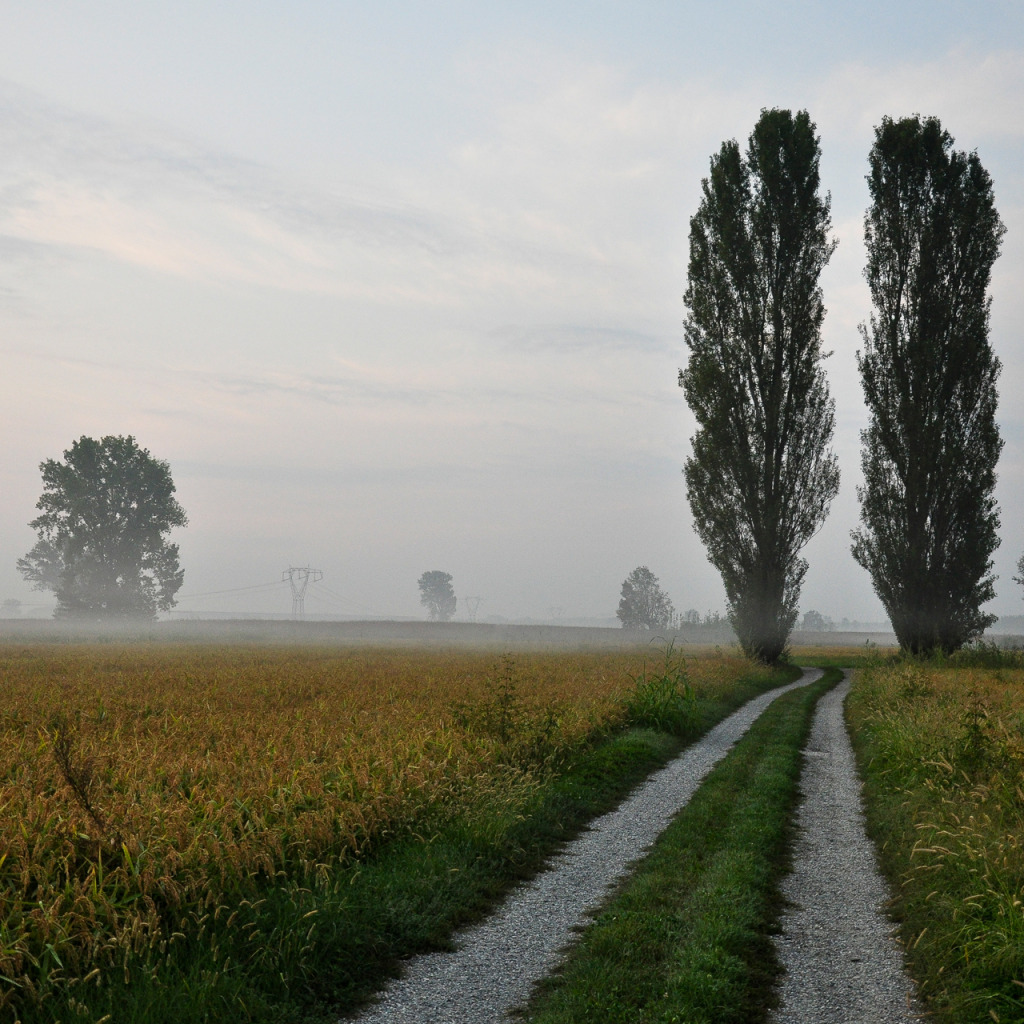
[348,670,819,1024]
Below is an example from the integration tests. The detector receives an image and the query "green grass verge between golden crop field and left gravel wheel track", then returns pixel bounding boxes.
[20,659,797,1024]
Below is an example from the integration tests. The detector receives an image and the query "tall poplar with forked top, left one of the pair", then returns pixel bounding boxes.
[679,110,839,664]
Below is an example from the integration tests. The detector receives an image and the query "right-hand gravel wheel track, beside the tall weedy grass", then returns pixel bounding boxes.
[773,677,923,1024]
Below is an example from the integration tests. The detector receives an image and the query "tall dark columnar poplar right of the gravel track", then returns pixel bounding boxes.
[853,117,1005,654]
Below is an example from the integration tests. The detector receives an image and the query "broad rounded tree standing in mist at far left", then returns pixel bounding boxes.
[17,436,187,618]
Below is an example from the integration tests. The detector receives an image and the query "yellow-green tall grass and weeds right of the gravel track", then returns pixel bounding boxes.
[847,648,1024,1024]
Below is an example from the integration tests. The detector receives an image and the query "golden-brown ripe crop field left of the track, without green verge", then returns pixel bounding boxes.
[0,644,770,1021]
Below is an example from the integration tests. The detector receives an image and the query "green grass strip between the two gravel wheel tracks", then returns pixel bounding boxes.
[516,669,841,1024]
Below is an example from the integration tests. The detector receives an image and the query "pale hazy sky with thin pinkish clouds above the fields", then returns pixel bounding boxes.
[0,0,1024,621]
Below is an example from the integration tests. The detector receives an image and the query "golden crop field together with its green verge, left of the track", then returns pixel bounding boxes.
[0,645,794,1024]
